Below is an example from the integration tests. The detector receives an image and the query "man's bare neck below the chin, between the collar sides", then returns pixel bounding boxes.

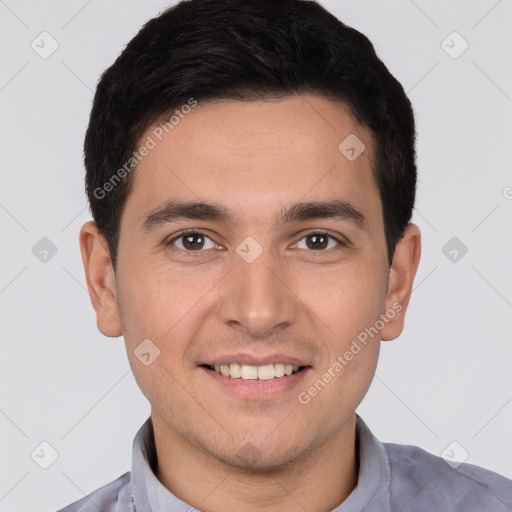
[152,416,358,512]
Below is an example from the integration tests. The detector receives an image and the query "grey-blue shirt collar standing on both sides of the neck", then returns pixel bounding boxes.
[131,415,391,512]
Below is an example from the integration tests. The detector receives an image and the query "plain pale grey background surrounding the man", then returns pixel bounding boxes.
[0,0,512,512]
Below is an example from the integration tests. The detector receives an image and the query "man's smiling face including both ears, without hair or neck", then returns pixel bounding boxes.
[81,96,419,468]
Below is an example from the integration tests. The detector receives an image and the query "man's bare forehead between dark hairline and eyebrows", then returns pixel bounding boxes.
[125,96,380,230]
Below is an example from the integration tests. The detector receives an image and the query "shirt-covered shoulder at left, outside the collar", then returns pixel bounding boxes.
[54,471,131,512]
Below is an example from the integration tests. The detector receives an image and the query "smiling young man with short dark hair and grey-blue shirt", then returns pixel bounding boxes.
[60,0,512,512]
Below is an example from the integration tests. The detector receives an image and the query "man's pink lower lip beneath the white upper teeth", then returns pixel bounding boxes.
[199,366,311,400]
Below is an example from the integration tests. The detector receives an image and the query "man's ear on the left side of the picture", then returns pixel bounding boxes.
[79,221,123,338]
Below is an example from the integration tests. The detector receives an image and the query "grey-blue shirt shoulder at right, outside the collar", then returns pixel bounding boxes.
[383,443,512,512]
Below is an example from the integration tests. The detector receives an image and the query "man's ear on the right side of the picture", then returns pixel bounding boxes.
[381,224,421,341]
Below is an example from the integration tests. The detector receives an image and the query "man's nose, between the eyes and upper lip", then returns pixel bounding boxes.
[217,245,299,338]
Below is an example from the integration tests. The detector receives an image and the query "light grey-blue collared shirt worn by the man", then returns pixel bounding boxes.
[59,416,512,512]
